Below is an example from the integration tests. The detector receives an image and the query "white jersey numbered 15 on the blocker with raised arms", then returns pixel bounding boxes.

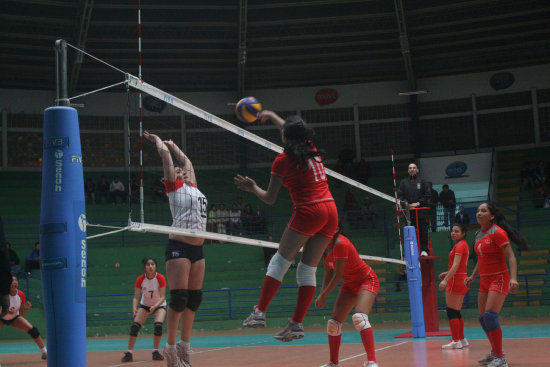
[164,180,208,231]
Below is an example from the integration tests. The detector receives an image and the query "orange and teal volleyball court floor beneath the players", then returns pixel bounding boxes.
[0,320,550,367]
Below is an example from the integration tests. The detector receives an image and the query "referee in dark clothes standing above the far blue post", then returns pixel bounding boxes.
[397,163,430,256]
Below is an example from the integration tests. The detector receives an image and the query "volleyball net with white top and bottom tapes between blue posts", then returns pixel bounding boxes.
[58,39,405,264]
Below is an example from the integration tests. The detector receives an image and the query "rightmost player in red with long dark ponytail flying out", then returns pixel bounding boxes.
[464,203,528,367]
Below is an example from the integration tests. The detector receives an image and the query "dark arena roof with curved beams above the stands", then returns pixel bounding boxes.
[0,0,550,92]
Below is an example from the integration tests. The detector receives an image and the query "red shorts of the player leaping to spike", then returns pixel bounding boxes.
[287,201,338,238]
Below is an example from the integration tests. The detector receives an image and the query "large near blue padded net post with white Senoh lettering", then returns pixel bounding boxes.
[40,106,87,367]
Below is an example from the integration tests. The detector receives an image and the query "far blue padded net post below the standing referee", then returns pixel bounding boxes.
[403,226,426,338]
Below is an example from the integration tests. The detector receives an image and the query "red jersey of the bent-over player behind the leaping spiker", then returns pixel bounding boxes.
[323,235,372,283]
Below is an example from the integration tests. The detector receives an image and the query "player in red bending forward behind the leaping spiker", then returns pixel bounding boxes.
[315,227,379,367]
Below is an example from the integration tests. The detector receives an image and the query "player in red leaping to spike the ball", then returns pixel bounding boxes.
[235,111,338,342]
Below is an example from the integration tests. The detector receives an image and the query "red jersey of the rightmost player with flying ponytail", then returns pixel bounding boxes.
[474,224,510,276]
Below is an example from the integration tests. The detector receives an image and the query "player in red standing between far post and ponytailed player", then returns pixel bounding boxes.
[439,223,470,349]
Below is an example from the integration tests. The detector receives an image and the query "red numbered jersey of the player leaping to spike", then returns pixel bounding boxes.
[271,153,334,206]
